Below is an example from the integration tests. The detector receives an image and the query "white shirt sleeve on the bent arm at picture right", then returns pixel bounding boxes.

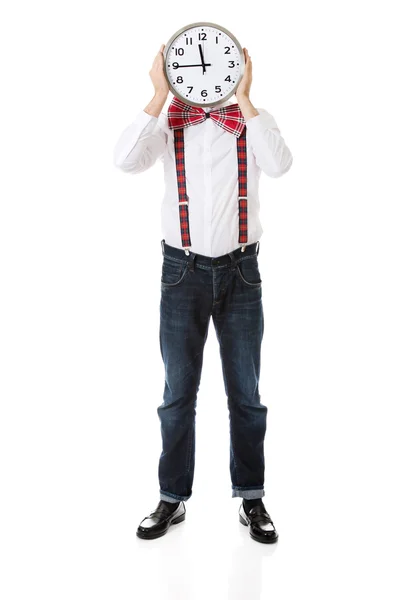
[246,108,293,177]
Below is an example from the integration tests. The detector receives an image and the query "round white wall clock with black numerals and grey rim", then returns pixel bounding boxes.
[164,23,245,106]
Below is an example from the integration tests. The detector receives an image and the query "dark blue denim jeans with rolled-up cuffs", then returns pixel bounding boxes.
[157,240,267,502]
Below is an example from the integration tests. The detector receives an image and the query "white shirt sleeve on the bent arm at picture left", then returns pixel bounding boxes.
[114,110,167,174]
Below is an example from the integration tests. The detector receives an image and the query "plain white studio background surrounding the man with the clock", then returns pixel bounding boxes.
[0,0,400,600]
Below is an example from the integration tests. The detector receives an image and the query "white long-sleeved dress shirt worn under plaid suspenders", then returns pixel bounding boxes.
[114,100,292,257]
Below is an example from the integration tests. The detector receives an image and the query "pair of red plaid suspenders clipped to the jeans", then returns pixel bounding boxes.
[173,127,247,254]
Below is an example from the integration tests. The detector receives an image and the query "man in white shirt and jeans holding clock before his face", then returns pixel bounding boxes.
[114,44,292,543]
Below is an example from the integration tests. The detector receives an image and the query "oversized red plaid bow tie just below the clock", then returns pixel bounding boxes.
[168,96,246,137]
